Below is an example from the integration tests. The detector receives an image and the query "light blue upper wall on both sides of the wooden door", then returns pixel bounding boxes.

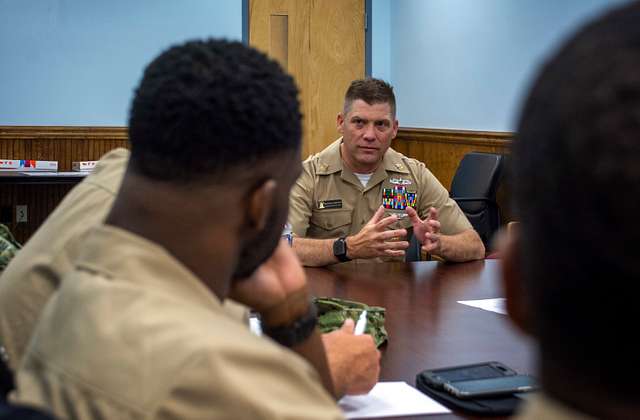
[0,0,624,131]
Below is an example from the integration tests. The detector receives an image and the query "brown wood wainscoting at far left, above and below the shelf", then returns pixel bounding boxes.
[0,126,128,243]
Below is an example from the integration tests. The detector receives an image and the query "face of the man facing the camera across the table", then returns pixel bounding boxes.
[338,99,398,173]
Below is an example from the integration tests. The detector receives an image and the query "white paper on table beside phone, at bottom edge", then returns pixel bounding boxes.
[338,382,451,419]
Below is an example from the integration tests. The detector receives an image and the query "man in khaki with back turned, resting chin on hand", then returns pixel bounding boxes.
[11,40,377,419]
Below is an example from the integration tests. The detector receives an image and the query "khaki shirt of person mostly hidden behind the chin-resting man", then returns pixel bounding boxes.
[0,148,246,370]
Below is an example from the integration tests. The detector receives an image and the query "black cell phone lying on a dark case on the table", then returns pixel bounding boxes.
[421,362,517,389]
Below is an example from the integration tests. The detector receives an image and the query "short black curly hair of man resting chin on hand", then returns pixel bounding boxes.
[129,39,301,183]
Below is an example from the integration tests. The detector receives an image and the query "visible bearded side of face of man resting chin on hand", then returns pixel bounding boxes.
[233,149,302,279]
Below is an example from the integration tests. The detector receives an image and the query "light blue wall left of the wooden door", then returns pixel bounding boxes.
[0,0,242,125]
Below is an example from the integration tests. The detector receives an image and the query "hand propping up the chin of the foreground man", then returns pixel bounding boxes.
[229,241,311,326]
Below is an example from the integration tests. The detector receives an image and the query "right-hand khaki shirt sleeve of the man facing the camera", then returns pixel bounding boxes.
[417,162,473,235]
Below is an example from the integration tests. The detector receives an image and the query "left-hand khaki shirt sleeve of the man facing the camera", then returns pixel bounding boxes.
[289,160,315,237]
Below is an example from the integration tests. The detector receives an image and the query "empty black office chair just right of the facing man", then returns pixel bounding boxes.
[449,152,504,250]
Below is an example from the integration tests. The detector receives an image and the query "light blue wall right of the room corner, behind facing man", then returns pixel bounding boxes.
[382,0,622,131]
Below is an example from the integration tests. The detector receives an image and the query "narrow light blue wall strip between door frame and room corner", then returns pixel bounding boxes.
[371,0,391,81]
